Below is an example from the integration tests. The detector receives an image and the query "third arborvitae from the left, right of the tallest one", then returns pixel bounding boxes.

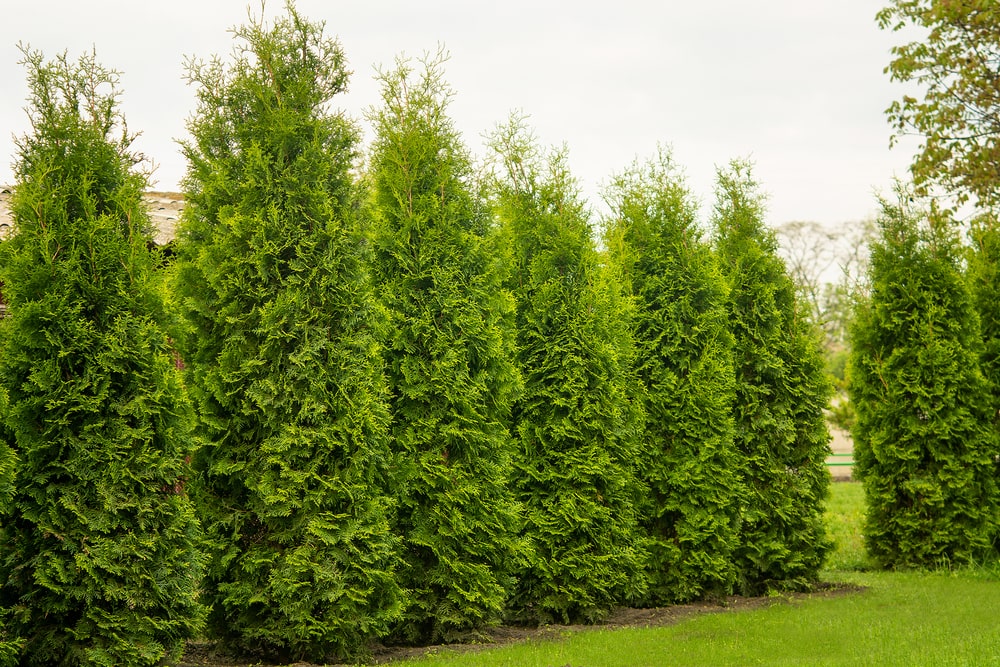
[371,58,522,641]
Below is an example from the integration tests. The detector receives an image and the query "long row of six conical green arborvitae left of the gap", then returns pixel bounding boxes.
[0,5,829,665]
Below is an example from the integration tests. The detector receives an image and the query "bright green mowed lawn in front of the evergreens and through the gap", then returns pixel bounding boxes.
[376,482,1000,667]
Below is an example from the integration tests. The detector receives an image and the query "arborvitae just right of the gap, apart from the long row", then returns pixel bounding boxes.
[848,197,998,567]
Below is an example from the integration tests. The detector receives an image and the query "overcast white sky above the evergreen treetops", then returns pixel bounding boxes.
[0,0,912,226]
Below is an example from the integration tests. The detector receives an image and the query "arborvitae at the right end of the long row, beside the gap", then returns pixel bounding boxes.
[714,162,831,594]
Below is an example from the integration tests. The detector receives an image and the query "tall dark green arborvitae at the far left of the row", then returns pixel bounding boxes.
[0,48,203,665]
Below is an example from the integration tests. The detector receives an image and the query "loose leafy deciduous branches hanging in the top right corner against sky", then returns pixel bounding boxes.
[878,0,1000,209]
